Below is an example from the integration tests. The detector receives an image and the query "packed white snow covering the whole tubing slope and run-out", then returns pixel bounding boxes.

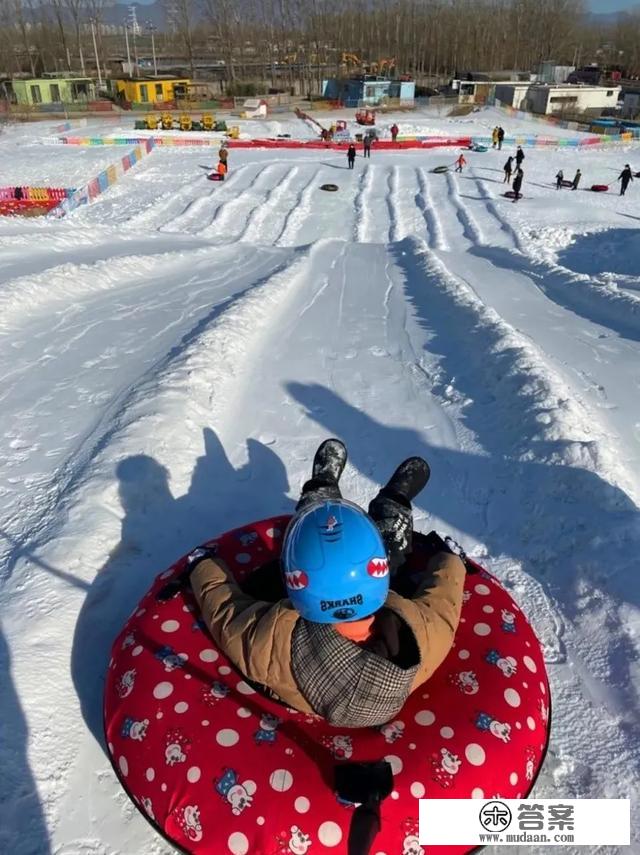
[0,110,640,855]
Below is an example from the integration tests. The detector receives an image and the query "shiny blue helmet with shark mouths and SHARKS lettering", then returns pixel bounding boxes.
[282,500,389,623]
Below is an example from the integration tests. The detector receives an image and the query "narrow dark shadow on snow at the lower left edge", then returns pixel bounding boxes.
[0,627,51,855]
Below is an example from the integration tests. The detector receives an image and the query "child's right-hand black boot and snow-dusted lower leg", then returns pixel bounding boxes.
[369,457,431,575]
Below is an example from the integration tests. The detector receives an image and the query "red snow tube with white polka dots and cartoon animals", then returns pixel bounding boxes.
[104,516,549,855]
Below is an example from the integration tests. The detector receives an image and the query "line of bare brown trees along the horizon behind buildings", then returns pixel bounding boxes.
[0,0,640,88]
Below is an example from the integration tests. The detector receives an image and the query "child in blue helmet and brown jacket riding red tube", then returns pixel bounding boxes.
[175,439,466,727]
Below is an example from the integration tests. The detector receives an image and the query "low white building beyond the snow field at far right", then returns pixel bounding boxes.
[495,83,620,116]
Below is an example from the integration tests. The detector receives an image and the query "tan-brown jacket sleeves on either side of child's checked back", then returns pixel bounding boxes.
[191,552,465,712]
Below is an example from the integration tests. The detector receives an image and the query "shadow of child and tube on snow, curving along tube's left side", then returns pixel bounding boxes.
[71,428,294,748]
